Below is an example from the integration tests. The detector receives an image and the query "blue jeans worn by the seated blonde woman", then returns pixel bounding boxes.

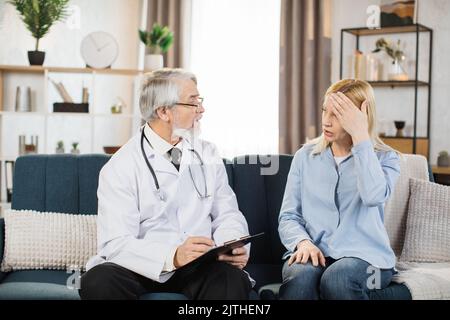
[279,258,395,300]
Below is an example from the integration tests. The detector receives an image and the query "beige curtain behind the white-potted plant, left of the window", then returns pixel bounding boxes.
[147,0,187,68]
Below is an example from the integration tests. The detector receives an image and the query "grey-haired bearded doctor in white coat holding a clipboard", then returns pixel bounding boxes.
[79,69,251,299]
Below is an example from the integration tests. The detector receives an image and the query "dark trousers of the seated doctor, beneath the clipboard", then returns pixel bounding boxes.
[79,261,252,300]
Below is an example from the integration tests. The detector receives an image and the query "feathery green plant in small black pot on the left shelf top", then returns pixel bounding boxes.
[8,0,69,65]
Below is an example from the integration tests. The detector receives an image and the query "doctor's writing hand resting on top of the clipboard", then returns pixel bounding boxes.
[173,237,214,268]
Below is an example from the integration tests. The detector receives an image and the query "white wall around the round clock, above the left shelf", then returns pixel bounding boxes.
[0,0,141,68]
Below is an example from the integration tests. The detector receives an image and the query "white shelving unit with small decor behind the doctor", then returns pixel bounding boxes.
[0,65,143,202]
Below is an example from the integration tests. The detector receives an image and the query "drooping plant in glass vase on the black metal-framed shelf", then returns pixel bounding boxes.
[372,38,408,81]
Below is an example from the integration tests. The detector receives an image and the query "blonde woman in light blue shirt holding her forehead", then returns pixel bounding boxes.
[278,79,400,299]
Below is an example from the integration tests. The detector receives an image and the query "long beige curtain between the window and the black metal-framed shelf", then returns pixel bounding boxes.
[279,0,331,154]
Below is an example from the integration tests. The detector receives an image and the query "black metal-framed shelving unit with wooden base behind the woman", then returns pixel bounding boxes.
[339,24,433,158]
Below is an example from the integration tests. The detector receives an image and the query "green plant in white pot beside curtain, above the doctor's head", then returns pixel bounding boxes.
[139,22,174,70]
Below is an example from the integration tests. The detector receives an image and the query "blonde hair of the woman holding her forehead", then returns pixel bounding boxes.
[307,79,398,155]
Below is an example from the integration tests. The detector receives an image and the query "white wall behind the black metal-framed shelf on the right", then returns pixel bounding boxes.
[332,0,450,164]
